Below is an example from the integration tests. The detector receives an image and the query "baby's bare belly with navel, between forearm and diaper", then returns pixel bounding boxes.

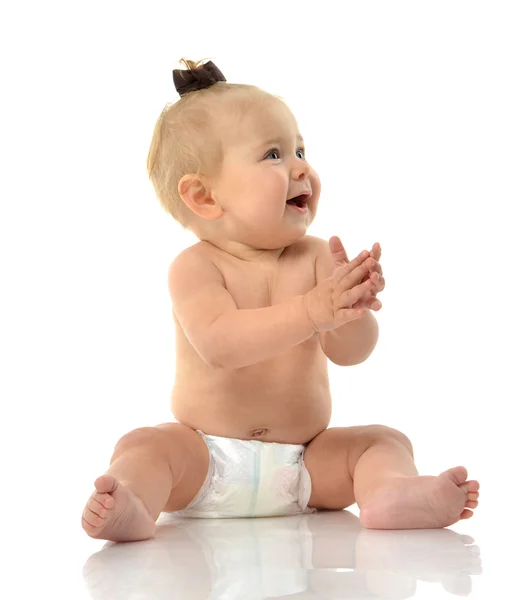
[171,336,331,444]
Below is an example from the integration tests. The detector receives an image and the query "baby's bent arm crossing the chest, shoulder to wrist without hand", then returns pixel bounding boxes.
[169,249,315,369]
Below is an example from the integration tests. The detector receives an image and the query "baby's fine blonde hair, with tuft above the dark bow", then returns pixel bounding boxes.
[146,58,278,229]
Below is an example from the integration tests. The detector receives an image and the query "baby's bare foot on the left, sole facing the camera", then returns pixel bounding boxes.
[82,475,156,542]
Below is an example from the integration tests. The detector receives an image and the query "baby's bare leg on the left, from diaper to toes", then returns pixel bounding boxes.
[82,423,209,542]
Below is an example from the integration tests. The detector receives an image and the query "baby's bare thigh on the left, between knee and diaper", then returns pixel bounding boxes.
[156,423,209,512]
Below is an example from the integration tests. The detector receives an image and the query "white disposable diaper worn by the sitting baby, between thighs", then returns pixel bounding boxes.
[173,430,316,519]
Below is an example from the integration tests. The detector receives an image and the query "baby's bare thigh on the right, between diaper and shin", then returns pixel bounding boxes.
[304,425,385,510]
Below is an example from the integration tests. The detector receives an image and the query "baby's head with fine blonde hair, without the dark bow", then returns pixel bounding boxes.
[147,59,320,255]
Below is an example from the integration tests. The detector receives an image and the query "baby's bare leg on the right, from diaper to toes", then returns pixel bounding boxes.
[304,425,479,529]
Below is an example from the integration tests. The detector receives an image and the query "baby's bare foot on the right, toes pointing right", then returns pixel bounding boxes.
[360,467,479,529]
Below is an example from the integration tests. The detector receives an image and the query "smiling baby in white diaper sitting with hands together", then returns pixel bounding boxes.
[82,59,479,542]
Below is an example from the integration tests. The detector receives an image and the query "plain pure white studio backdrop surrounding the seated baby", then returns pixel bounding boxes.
[0,0,527,597]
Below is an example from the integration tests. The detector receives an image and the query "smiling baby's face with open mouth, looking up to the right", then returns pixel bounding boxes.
[213,101,320,249]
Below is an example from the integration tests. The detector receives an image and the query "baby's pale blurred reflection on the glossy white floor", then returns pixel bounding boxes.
[84,511,482,600]
